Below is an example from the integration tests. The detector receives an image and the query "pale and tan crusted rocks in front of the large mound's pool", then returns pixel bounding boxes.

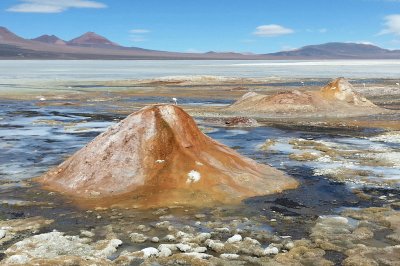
[0,202,400,265]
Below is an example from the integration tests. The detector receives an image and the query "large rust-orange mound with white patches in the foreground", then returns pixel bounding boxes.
[38,105,298,207]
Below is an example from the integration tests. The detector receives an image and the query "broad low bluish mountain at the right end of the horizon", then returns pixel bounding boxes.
[268,42,400,59]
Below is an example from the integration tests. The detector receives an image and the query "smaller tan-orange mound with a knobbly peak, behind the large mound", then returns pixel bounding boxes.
[227,78,383,116]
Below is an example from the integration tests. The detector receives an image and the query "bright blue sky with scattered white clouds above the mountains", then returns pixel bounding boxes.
[0,0,400,53]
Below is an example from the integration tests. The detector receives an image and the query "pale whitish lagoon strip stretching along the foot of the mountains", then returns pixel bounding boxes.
[0,60,400,84]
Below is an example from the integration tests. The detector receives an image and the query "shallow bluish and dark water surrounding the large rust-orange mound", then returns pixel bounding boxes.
[0,97,400,262]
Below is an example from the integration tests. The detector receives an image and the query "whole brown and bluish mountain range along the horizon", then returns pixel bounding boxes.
[0,27,400,60]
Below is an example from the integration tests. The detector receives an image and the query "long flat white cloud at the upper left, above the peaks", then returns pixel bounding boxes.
[7,0,107,13]
